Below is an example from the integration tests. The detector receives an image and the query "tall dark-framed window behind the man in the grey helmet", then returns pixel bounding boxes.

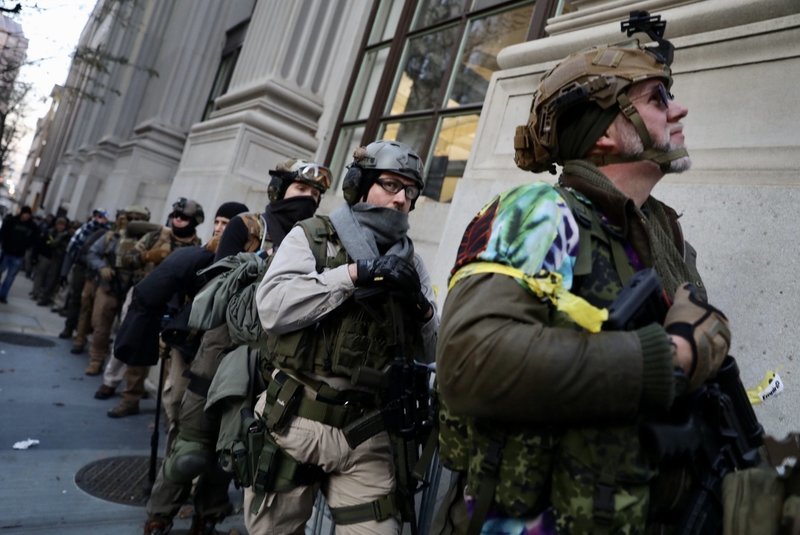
[328,0,557,202]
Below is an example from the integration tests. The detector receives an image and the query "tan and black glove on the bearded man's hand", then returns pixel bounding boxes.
[664,283,731,391]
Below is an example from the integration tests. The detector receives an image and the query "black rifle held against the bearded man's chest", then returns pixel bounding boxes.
[604,269,764,535]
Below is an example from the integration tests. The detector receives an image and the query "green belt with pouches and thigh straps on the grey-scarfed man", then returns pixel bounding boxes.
[231,370,399,525]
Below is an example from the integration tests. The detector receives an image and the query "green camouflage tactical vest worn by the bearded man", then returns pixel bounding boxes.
[439,187,700,533]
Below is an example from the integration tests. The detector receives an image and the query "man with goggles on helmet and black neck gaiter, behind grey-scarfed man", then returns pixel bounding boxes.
[144,159,331,535]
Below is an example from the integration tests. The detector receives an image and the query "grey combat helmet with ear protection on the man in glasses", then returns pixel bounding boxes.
[342,140,425,209]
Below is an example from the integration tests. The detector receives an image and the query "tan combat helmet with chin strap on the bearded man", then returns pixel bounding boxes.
[514,11,687,173]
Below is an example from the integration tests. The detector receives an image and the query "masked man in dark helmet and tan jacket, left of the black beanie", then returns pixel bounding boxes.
[106,197,205,418]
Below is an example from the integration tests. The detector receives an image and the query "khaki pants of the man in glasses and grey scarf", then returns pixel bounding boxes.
[244,393,400,535]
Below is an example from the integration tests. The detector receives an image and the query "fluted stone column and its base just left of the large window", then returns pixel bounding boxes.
[170,0,370,237]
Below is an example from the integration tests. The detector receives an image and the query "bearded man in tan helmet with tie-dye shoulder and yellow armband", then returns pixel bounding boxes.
[436,12,730,534]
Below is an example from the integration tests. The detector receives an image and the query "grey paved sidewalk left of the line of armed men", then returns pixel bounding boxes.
[0,273,246,535]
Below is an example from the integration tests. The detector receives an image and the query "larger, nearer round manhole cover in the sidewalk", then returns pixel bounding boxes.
[75,457,161,507]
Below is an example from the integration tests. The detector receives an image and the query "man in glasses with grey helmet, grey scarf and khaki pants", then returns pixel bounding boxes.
[245,141,438,534]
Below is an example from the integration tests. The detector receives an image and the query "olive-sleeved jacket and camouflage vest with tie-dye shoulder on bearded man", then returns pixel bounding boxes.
[436,161,699,533]
